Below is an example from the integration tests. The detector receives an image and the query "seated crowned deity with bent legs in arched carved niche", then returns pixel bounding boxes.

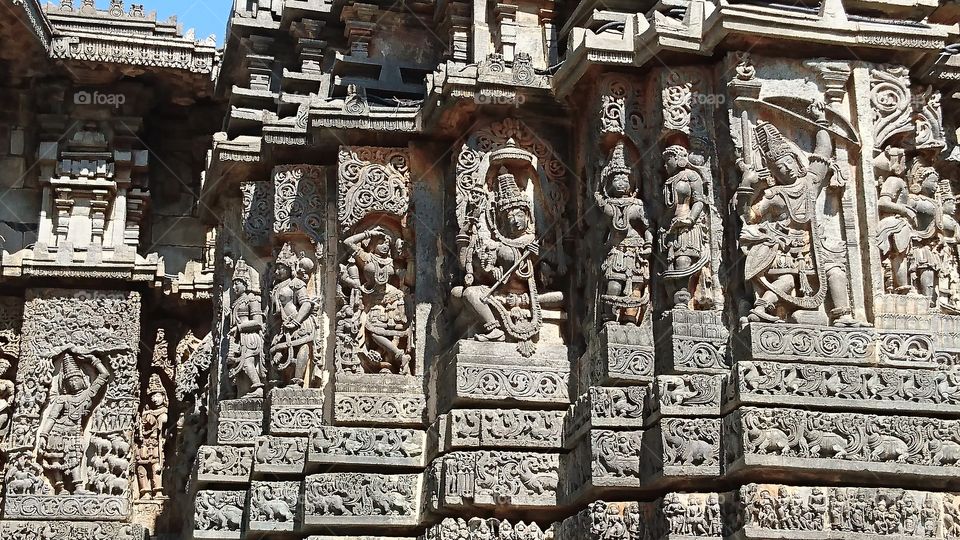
[451,119,568,356]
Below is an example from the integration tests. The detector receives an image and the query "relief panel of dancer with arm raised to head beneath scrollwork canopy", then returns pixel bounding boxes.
[337,147,416,375]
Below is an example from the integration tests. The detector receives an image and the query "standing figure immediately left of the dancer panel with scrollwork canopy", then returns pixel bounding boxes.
[270,244,318,386]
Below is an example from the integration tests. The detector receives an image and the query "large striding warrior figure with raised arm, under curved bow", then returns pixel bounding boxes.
[735,100,864,327]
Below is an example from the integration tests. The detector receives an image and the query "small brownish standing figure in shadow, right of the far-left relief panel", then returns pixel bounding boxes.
[137,373,169,498]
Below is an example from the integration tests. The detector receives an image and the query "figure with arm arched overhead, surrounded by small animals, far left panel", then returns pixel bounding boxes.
[37,346,110,495]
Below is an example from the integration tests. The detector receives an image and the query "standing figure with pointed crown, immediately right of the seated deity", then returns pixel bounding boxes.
[593,141,653,324]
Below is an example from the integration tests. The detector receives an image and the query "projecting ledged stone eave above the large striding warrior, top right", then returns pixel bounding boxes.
[703,4,957,53]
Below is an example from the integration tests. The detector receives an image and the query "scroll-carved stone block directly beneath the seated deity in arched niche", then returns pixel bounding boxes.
[439,340,570,410]
